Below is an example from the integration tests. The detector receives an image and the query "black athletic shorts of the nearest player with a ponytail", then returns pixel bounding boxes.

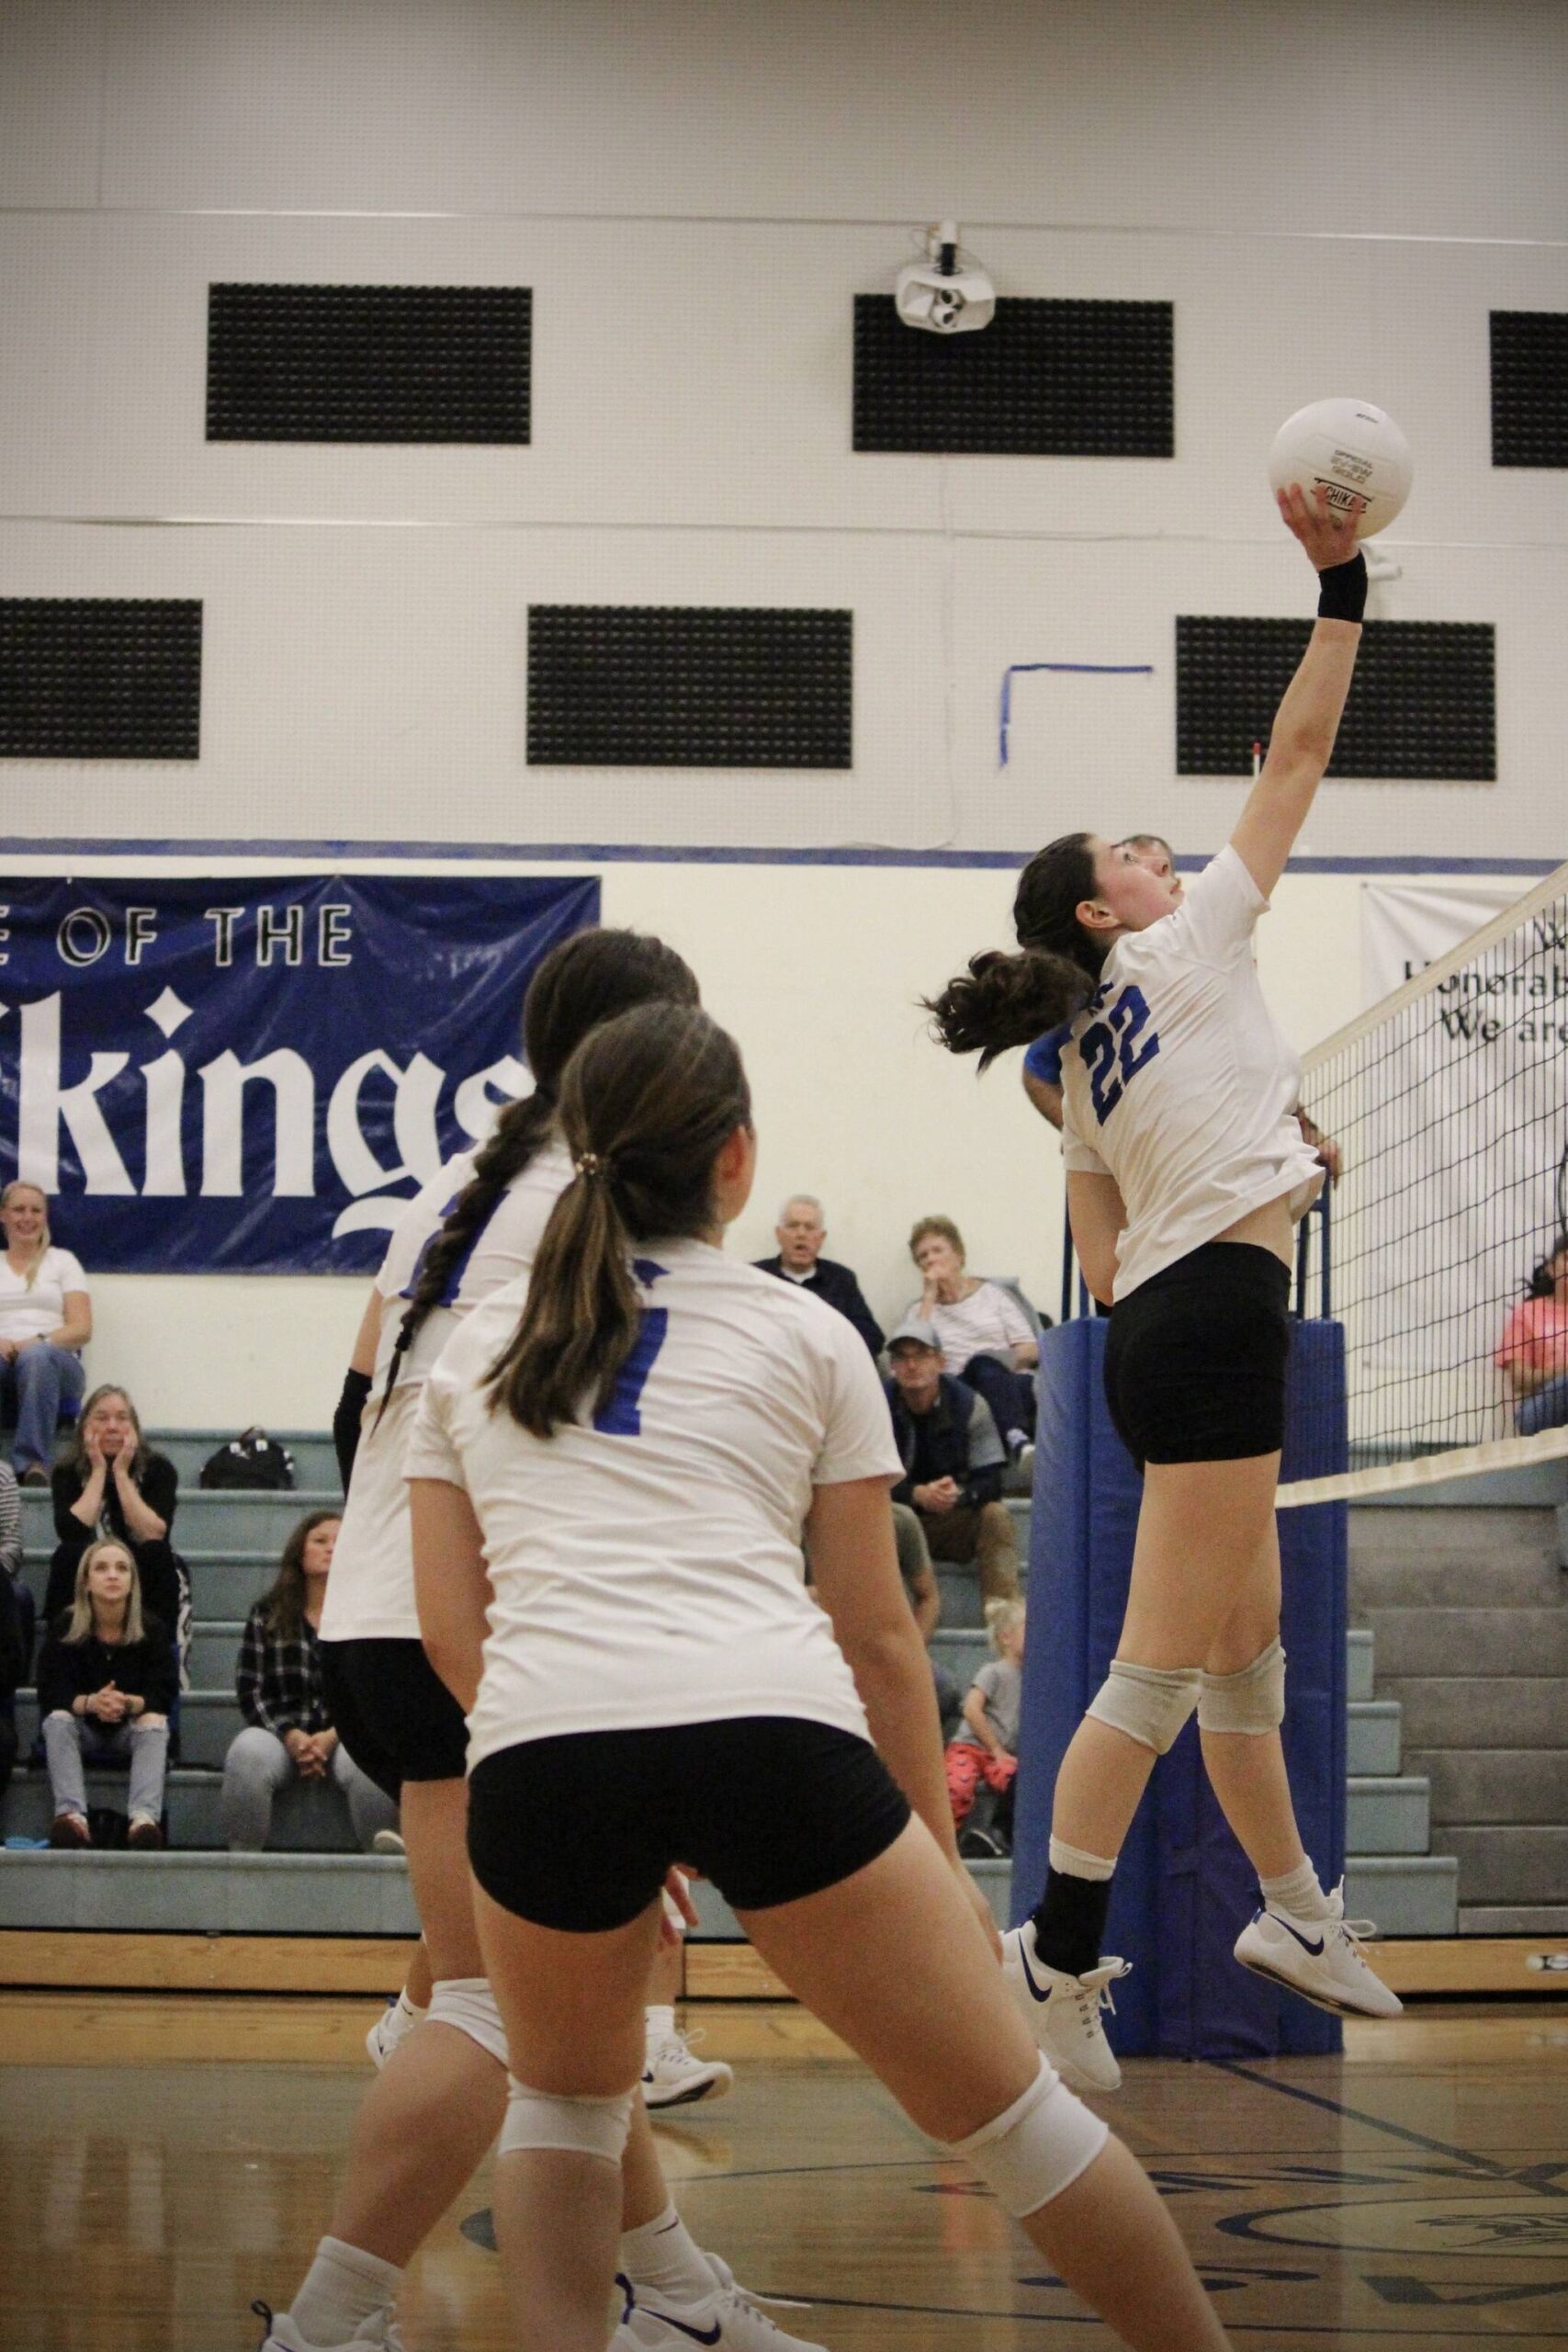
[468,1714,909,1936]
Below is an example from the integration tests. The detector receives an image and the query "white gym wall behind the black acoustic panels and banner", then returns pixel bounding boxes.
[0,0,1568,1425]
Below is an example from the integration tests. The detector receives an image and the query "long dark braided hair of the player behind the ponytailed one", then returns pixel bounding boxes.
[376,929,698,1420]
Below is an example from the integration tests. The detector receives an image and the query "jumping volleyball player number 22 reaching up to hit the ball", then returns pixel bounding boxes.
[931,484,1401,2091]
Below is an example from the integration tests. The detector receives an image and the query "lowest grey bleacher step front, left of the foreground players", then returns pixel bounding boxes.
[0,1849,419,1936]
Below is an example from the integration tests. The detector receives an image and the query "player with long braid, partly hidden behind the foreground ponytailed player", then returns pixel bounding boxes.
[256,932,816,2352]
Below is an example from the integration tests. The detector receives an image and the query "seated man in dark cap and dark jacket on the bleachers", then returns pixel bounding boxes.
[886,1317,1018,1601]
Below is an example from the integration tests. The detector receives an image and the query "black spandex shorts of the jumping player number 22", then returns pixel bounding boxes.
[1105,1242,1291,1470]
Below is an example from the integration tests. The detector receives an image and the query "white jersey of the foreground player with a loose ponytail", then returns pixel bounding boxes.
[404,1239,903,1769]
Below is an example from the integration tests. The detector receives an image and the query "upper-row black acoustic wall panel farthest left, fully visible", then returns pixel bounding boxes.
[207,285,534,442]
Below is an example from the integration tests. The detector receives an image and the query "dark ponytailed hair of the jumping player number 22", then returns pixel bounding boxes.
[921,832,1110,1070]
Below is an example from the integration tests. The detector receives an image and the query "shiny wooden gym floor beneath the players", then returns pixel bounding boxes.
[0,1992,1568,2352]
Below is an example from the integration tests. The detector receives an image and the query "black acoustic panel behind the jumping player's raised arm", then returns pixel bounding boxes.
[1176,614,1497,783]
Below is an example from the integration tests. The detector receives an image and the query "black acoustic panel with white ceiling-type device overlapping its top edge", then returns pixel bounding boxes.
[856,294,1176,457]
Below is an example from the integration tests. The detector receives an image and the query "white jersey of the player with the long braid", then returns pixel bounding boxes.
[322,1138,571,1642]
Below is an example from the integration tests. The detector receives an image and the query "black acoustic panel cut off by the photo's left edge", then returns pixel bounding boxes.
[0,597,202,760]
